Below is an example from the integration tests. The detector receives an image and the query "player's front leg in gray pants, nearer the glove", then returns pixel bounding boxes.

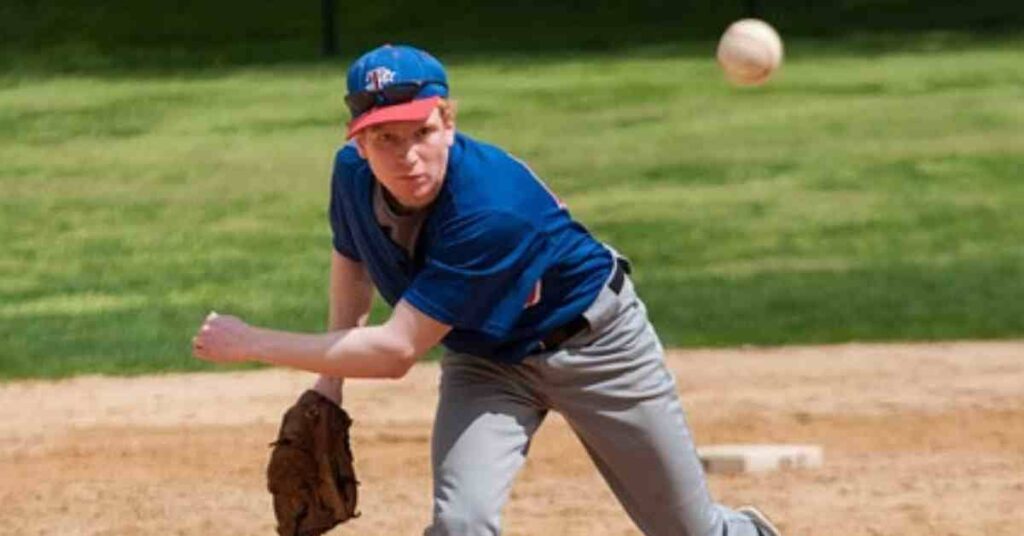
[425,355,546,536]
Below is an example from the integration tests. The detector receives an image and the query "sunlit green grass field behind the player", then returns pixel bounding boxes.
[0,37,1024,378]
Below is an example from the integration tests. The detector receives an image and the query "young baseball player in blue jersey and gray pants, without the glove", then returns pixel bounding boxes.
[194,45,778,536]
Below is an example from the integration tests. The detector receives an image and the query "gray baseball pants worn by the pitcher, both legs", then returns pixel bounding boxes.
[425,278,758,536]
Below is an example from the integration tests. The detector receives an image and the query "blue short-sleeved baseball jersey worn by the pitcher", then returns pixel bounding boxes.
[330,133,612,362]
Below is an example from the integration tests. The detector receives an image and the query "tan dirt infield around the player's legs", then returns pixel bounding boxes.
[0,341,1024,536]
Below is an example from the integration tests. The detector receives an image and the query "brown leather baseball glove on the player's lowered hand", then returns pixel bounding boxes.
[266,389,359,536]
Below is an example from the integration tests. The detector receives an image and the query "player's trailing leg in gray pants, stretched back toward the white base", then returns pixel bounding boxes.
[532,284,759,536]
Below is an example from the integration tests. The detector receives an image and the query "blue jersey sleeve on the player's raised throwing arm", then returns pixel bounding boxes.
[402,211,549,337]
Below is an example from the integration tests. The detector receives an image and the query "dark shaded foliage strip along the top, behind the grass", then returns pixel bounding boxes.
[0,0,1024,72]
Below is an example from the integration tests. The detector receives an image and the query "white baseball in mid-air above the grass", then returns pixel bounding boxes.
[717,18,782,86]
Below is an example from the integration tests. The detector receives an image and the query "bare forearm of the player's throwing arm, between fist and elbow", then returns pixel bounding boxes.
[250,326,419,378]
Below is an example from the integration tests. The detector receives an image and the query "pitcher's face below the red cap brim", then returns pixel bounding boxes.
[355,110,455,208]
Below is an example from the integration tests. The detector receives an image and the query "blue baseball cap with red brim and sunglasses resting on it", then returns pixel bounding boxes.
[345,45,449,137]
